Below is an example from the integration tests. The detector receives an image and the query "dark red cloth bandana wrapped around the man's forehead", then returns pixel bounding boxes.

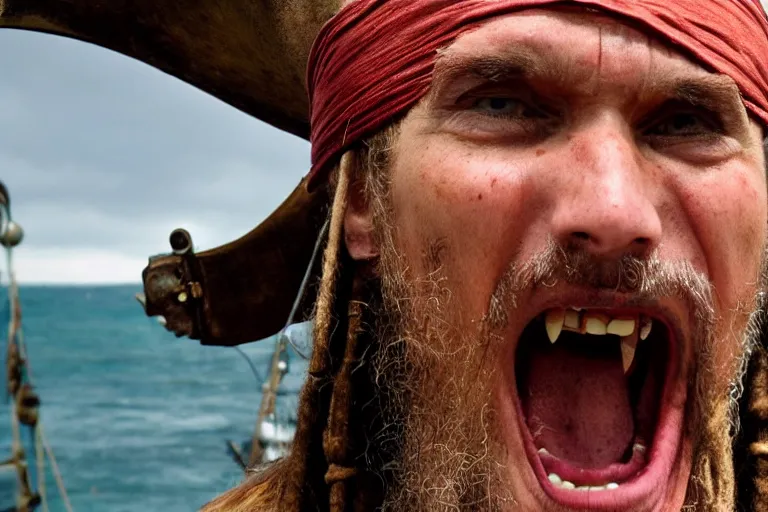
[307,0,768,186]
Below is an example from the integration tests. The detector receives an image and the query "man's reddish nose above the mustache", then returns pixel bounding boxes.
[552,120,662,259]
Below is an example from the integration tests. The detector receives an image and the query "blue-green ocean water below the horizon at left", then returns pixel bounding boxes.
[0,286,307,512]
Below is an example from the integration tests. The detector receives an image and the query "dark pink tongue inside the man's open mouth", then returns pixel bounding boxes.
[521,336,634,469]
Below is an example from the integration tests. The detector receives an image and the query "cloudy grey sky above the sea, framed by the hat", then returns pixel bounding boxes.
[0,4,765,283]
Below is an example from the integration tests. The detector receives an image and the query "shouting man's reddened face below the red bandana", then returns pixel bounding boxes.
[347,7,768,510]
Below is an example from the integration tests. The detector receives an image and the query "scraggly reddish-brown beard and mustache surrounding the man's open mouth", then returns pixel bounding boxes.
[372,194,765,511]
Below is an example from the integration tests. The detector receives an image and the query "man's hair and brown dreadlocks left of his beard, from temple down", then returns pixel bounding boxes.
[203,125,397,512]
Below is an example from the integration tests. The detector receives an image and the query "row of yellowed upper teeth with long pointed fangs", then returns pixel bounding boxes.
[544,308,653,373]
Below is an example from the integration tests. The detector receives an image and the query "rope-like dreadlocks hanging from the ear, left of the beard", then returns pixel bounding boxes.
[280,152,390,512]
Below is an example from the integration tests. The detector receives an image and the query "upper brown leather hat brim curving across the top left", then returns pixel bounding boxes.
[0,0,340,139]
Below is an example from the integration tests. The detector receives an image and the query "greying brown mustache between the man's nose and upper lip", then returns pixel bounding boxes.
[486,239,715,330]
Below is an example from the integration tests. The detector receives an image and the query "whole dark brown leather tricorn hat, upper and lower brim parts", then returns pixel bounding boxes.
[0,0,341,345]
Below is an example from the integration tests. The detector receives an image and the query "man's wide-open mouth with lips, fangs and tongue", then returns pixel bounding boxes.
[515,308,681,510]
